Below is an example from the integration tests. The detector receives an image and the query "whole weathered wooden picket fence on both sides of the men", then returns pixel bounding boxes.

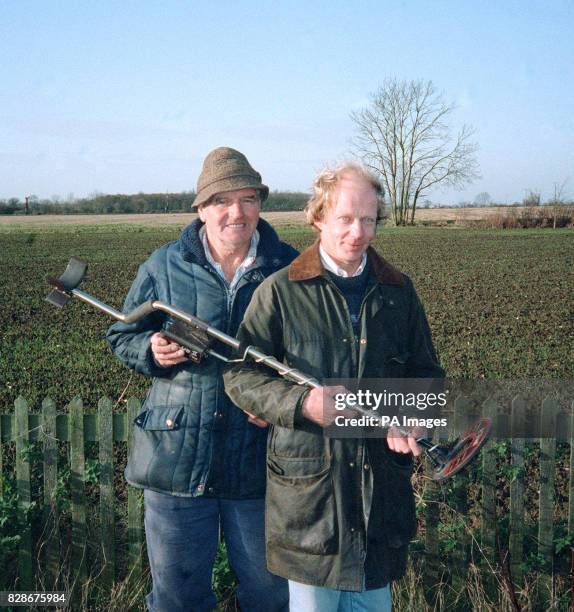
[0,397,574,604]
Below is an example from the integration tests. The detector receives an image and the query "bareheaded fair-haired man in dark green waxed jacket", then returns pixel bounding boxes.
[225,164,444,612]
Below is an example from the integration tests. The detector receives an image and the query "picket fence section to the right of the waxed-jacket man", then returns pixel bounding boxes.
[424,396,574,605]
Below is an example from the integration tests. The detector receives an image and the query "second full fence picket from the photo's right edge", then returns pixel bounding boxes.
[508,396,526,586]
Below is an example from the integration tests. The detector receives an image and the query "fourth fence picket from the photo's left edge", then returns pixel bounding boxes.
[98,397,116,593]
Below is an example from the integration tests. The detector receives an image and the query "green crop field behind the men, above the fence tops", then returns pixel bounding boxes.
[0,226,574,411]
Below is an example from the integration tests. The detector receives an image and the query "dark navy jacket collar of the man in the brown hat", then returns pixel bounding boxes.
[179,219,285,267]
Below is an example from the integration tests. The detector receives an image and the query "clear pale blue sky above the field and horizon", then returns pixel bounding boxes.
[0,0,574,203]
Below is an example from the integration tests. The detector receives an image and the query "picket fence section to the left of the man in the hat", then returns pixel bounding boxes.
[0,397,144,604]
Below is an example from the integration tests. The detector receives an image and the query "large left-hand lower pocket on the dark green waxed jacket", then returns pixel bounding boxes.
[265,455,338,555]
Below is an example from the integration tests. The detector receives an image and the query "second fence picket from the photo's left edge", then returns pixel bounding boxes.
[42,398,60,589]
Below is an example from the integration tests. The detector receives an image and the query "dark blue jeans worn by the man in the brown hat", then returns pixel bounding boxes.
[144,490,289,612]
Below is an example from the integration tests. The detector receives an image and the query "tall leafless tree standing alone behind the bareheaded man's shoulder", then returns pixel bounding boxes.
[351,79,478,225]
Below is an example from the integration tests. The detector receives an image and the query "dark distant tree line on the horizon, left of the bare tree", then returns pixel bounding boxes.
[0,191,309,215]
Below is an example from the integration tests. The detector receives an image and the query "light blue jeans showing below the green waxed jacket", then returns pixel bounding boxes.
[289,580,391,612]
